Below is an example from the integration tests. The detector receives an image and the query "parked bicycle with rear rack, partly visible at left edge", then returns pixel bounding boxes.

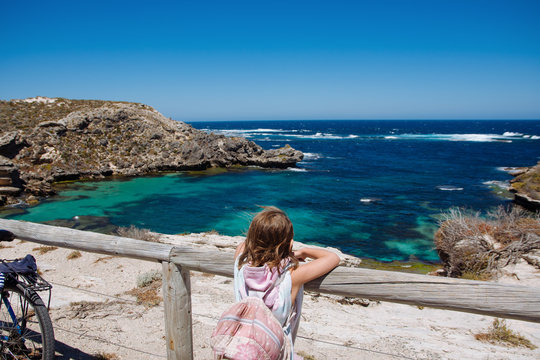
[0,230,55,360]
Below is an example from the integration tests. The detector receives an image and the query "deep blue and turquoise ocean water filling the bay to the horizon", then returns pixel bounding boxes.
[0,120,540,262]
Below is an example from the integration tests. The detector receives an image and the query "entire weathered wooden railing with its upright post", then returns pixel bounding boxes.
[0,219,540,359]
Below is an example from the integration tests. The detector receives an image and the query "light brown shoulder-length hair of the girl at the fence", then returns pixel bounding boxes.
[238,206,298,270]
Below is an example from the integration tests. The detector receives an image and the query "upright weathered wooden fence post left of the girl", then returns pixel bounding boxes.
[162,261,193,360]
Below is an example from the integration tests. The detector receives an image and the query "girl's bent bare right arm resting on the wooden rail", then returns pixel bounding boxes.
[291,248,339,299]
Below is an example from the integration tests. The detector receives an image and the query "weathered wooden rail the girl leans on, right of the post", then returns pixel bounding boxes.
[171,247,540,322]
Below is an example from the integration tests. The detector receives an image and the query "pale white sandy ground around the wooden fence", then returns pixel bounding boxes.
[1,235,540,360]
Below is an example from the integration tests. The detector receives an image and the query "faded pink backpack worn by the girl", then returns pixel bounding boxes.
[210,297,290,360]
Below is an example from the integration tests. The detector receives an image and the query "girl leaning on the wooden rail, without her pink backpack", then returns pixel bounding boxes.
[234,207,339,359]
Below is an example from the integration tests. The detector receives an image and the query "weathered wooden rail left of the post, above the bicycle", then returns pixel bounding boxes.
[0,219,173,261]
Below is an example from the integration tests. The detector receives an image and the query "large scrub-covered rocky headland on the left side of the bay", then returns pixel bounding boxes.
[0,97,303,205]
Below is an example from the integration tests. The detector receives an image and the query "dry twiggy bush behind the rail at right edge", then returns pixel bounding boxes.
[435,207,540,280]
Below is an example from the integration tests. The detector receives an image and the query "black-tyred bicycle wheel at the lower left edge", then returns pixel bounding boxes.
[0,284,54,360]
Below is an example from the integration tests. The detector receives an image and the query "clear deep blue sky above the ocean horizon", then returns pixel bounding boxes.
[0,0,540,121]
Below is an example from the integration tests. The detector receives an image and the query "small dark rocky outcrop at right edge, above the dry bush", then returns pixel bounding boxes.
[510,162,540,211]
